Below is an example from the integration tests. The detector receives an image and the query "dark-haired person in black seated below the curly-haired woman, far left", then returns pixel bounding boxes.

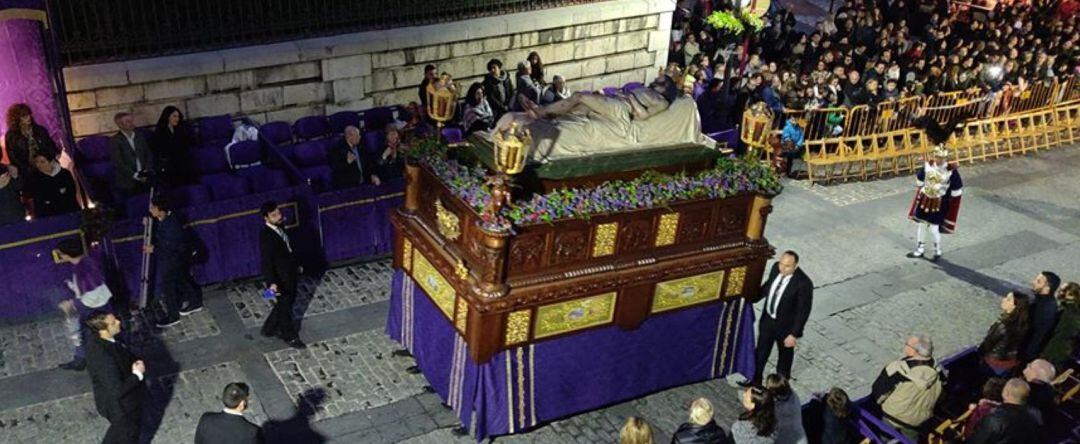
[23,151,79,217]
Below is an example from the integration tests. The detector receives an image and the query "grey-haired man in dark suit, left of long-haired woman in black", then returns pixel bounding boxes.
[109,112,153,203]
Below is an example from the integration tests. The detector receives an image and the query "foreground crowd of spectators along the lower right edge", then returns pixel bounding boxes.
[620,271,1080,444]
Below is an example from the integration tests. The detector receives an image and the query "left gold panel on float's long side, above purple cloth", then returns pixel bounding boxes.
[532,292,616,339]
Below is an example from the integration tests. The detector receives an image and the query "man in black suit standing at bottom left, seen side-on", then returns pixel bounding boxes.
[86,312,146,444]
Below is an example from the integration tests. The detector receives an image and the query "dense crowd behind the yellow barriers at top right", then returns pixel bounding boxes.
[665,0,1080,132]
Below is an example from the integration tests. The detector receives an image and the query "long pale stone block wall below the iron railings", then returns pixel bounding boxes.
[64,0,675,137]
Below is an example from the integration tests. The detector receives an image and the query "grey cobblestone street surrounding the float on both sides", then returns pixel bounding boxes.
[0,147,1080,444]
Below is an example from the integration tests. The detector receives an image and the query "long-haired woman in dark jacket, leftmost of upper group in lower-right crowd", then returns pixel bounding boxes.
[978,293,1030,376]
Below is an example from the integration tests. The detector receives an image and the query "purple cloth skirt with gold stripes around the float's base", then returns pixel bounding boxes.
[387,270,754,440]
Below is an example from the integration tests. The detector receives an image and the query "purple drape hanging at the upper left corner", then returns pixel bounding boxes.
[0,17,67,159]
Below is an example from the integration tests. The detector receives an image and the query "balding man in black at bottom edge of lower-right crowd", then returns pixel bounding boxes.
[967,378,1043,444]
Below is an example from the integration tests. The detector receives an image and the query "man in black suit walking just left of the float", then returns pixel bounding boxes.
[259,202,307,349]
